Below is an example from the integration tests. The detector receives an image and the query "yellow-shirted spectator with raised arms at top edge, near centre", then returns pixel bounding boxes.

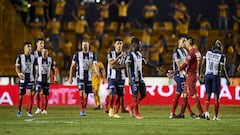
[114,0,132,35]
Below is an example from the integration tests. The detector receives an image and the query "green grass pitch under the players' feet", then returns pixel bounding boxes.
[0,106,240,135]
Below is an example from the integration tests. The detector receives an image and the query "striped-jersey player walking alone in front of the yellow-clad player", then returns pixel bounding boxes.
[68,40,99,116]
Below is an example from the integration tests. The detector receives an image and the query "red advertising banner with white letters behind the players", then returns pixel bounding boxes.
[0,84,240,105]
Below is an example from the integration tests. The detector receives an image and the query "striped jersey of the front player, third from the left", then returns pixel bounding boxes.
[36,57,56,83]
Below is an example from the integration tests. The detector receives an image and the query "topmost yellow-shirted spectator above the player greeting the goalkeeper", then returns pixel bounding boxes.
[171,0,187,37]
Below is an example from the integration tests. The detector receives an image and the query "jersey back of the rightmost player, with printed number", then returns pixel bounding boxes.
[203,50,226,76]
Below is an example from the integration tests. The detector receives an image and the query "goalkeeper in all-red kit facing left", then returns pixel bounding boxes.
[172,37,204,118]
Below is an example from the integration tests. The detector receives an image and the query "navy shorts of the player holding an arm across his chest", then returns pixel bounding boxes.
[109,79,125,96]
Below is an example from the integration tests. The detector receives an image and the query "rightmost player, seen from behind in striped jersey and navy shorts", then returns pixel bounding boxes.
[200,40,230,120]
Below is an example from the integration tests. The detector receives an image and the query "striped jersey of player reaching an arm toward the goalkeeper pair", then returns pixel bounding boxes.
[125,51,147,82]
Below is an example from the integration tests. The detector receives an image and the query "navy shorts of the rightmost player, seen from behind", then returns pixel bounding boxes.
[205,75,220,94]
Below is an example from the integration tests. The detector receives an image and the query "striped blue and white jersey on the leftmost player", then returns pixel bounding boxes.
[15,53,35,82]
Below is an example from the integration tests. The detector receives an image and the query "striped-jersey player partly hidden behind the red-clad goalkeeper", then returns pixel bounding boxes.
[169,37,196,118]
